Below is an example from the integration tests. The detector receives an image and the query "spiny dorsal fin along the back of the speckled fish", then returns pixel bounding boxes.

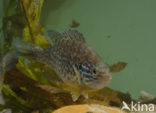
[48,30,85,43]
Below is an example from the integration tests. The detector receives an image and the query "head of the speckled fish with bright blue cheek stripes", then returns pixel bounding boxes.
[81,61,112,90]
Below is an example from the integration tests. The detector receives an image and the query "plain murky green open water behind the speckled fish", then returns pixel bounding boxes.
[0,0,156,98]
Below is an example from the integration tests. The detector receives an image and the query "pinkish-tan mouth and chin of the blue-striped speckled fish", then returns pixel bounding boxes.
[89,73,112,90]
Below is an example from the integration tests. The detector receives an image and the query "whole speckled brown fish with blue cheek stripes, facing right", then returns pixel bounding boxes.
[13,30,111,101]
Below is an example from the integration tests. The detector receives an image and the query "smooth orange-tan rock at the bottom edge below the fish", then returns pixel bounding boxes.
[53,104,127,113]
